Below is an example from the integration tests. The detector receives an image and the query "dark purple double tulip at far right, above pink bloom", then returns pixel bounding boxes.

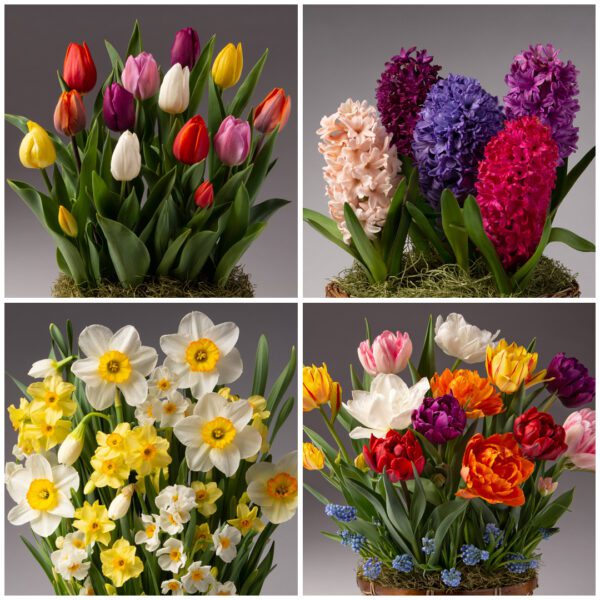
[546,352,596,408]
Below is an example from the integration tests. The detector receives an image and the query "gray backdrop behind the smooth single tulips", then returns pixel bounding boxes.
[5,5,298,297]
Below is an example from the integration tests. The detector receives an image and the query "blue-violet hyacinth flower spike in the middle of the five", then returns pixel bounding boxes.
[412,75,504,209]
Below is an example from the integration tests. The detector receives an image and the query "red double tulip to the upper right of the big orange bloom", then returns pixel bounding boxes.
[514,406,567,460]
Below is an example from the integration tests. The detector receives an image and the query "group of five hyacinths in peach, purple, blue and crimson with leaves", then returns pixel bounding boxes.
[304,44,595,296]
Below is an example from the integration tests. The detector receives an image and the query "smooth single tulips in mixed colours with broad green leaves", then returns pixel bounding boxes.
[6,22,291,295]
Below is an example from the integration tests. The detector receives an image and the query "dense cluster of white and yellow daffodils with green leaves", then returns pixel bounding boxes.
[6,312,298,596]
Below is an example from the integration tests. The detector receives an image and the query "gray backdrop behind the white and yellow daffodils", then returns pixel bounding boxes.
[4,303,298,595]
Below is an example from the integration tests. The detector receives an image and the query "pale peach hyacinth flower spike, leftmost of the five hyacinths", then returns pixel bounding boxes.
[317,99,400,244]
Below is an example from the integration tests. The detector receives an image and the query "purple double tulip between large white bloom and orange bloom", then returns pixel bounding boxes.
[412,394,467,444]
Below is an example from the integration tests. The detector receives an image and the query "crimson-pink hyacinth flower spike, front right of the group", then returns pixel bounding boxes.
[476,117,558,269]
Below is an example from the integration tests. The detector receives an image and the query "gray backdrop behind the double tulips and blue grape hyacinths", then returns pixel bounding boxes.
[303,303,595,595]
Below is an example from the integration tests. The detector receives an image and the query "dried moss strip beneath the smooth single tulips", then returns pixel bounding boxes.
[52,267,254,298]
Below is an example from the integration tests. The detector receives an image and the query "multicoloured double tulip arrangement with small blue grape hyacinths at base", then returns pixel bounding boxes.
[303,313,596,594]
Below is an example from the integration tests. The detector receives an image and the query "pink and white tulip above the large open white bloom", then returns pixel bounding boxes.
[358,331,412,376]
